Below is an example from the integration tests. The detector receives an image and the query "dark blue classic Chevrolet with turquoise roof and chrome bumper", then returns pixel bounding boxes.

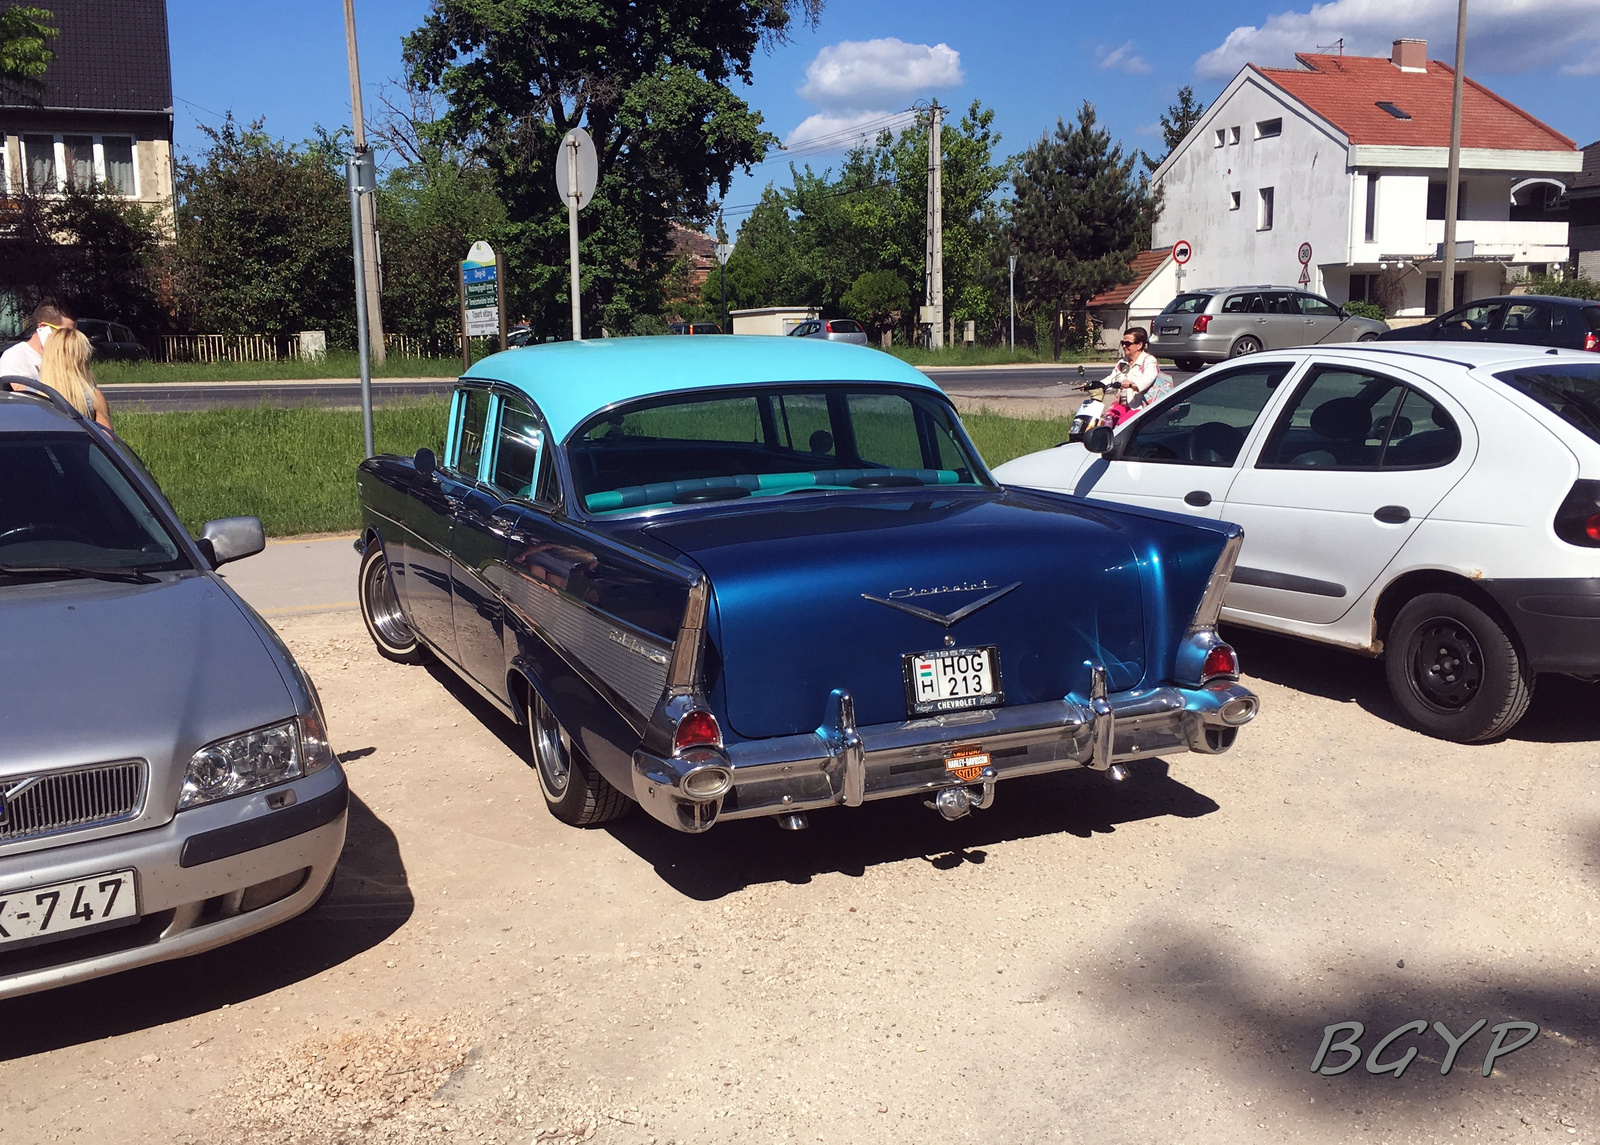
[357,337,1258,832]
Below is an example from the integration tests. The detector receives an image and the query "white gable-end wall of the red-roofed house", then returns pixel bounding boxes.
[1154,69,1350,291]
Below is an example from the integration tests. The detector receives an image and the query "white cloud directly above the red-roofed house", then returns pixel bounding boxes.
[1195,0,1600,80]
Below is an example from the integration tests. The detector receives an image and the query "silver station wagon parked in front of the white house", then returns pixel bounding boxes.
[1150,286,1389,369]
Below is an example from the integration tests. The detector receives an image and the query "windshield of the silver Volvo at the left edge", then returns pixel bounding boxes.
[0,433,189,574]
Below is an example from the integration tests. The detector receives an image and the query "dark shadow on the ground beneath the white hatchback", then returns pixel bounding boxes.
[1224,625,1600,744]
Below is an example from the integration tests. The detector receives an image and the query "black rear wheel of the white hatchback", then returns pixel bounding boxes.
[1384,592,1533,744]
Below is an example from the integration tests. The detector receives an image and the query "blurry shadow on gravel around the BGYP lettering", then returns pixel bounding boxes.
[1075,924,1600,1140]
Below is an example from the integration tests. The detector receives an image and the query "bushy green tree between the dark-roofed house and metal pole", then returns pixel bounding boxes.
[170,115,355,345]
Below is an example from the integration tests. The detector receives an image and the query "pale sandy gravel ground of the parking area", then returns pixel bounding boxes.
[0,612,1600,1145]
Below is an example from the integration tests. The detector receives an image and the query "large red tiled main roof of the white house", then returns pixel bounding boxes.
[1256,54,1578,150]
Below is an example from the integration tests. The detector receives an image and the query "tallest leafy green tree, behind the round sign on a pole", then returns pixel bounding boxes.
[405,0,821,336]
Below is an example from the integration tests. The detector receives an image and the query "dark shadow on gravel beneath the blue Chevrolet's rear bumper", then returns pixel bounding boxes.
[606,760,1218,900]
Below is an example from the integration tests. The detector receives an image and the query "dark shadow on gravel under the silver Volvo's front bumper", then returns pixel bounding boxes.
[0,795,414,1060]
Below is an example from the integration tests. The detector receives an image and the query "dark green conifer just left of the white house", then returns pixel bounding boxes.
[1011,102,1150,357]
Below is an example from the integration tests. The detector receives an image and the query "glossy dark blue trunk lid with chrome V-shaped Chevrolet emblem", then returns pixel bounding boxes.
[646,489,1146,739]
